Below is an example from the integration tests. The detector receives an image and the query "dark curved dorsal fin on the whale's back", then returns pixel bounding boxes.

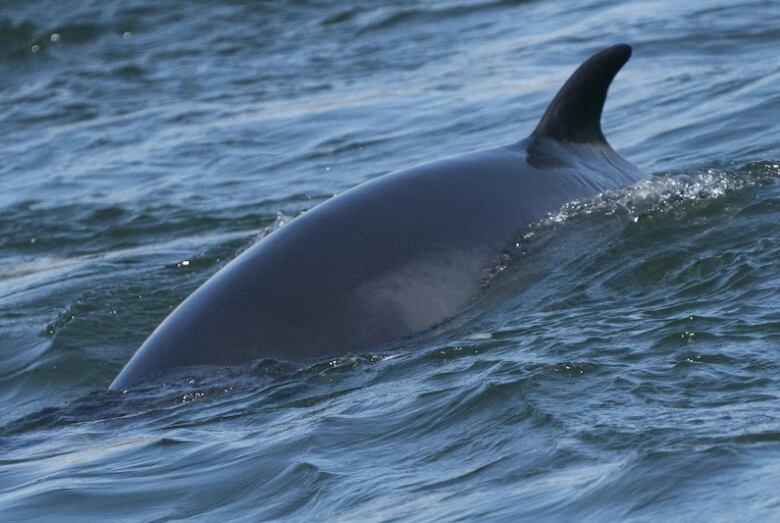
[531,44,631,143]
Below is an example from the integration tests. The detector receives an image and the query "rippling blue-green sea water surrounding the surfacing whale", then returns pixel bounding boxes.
[0,0,780,522]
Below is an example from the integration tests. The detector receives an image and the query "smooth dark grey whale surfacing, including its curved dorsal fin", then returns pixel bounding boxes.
[110,45,643,389]
